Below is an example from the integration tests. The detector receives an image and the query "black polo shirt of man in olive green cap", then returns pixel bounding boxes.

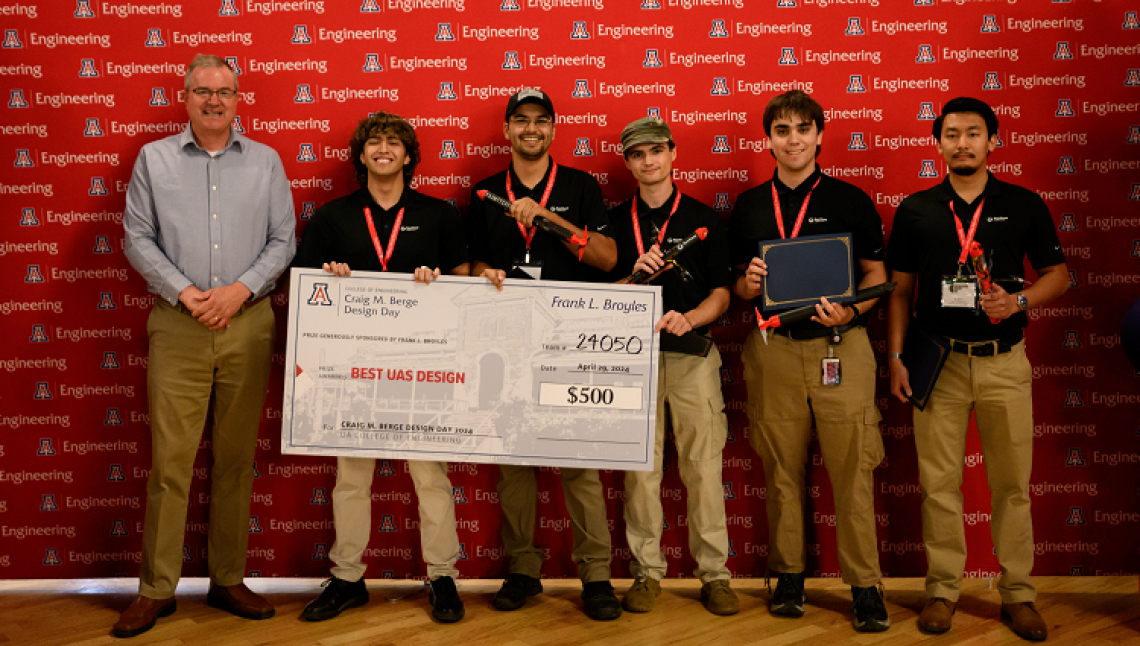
[610,186,732,328]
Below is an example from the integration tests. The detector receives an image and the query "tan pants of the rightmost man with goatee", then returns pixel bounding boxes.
[914,342,1037,603]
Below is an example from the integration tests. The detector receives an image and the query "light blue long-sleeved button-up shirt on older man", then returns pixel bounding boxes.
[123,125,296,305]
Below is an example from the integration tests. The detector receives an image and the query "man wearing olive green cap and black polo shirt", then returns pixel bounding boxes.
[610,117,740,615]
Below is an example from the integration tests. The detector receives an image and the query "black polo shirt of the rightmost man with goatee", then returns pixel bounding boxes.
[887,173,1065,341]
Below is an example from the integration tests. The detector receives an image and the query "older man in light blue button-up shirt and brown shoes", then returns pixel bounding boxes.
[114,55,296,637]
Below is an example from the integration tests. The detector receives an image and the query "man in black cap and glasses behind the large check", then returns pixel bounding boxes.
[467,89,621,620]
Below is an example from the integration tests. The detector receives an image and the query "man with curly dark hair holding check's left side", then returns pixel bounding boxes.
[293,112,470,623]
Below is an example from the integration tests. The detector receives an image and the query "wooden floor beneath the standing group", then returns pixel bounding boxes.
[0,577,1140,646]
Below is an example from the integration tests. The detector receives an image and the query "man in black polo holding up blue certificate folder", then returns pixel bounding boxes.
[728,90,890,632]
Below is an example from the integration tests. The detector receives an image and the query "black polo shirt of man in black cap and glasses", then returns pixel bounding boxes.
[467,158,611,283]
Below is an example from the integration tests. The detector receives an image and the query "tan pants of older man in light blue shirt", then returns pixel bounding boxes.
[139,299,275,599]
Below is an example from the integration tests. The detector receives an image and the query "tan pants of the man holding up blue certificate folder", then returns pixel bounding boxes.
[742,327,884,588]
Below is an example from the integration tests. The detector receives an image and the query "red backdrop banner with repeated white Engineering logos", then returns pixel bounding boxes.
[0,0,1140,578]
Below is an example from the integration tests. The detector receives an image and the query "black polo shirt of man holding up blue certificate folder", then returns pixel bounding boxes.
[728,166,886,329]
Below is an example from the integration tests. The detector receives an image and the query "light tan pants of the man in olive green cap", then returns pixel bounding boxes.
[625,347,732,583]
